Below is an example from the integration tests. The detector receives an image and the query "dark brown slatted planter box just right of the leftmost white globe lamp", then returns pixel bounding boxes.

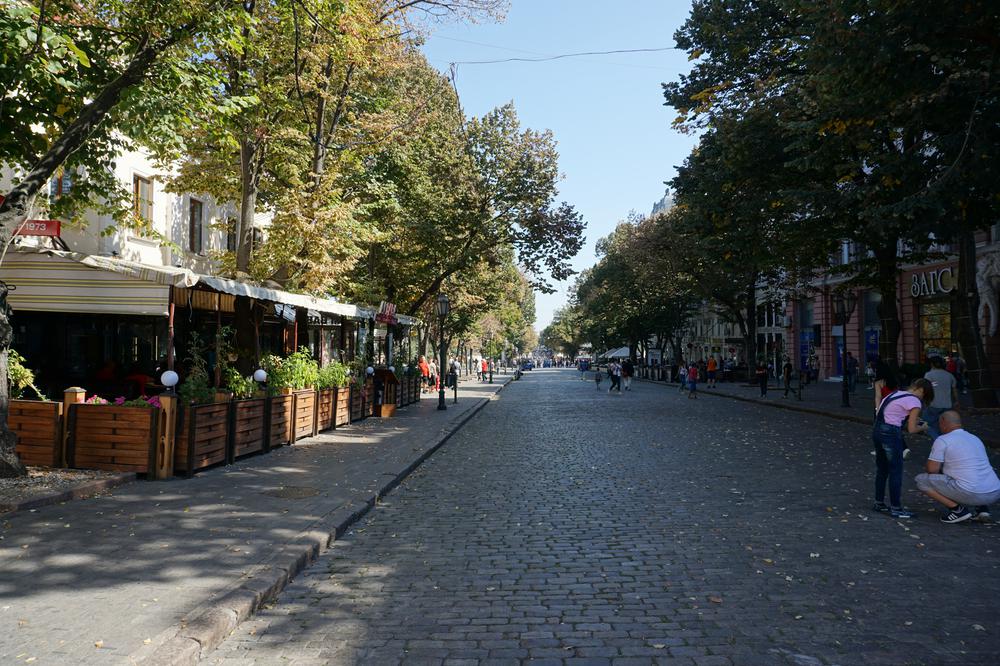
[174,402,231,476]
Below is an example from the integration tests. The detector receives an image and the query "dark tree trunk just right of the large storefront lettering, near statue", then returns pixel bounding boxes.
[951,232,998,407]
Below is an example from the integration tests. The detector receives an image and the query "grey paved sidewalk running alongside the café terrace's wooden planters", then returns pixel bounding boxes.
[0,375,512,664]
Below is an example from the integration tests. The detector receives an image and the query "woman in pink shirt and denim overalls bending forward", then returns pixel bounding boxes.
[872,378,934,518]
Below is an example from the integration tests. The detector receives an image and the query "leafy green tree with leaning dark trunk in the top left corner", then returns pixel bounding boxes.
[0,0,243,476]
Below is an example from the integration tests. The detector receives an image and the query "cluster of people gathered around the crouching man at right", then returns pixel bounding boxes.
[872,357,1000,524]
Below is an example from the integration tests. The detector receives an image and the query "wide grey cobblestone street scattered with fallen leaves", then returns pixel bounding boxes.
[206,370,1000,666]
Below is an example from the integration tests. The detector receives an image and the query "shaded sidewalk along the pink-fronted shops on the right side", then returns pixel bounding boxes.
[656,381,1000,448]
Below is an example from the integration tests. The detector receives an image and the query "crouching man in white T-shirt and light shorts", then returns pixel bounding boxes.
[916,410,1000,523]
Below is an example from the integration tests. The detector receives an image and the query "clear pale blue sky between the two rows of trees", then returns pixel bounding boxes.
[423,0,694,331]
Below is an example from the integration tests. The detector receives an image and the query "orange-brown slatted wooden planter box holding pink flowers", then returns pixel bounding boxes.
[66,404,160,474]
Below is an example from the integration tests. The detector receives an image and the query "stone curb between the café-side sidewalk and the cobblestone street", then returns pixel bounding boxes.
[133,377,513,666]
